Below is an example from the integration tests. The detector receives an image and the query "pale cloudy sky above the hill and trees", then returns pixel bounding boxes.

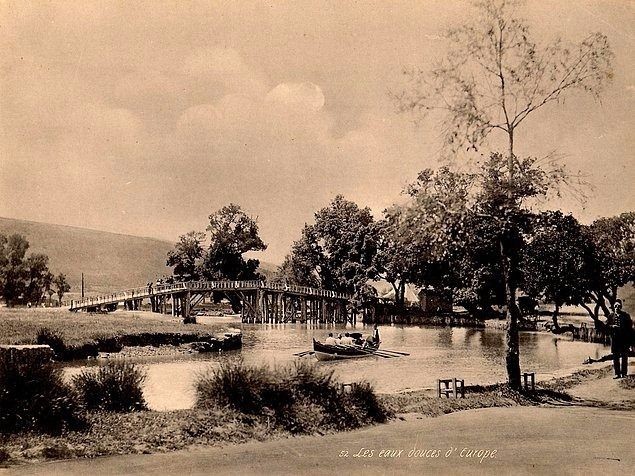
[0,0,635,262]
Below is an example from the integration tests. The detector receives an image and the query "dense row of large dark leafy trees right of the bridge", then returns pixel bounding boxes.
[279,154,635,327]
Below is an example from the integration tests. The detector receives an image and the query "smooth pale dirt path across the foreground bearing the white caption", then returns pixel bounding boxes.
[0,407,635,476]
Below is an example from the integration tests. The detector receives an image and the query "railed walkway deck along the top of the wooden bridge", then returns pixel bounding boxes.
[70,281,351,311]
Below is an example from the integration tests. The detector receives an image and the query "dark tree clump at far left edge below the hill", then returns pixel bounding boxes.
[0,234,71,306]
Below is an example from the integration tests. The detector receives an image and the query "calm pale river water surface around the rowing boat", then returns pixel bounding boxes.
[71,323,608,410]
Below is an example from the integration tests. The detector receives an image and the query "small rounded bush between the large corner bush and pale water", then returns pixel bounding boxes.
[73,362,147,413]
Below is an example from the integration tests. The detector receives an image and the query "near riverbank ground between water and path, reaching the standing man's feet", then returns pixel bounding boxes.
[0,366,635,471]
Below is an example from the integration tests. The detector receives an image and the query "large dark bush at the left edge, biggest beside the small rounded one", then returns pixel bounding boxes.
[0,353,85,434]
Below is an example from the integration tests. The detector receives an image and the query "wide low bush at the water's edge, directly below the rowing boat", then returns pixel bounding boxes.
[196,360,390,433]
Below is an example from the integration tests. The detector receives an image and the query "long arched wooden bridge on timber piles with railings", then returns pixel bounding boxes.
[70,281,356,323]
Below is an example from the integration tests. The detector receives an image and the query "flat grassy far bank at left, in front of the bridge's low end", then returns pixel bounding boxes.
[0,308,239,360]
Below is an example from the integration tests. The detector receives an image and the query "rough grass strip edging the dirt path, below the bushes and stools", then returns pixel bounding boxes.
[0,368,632,465]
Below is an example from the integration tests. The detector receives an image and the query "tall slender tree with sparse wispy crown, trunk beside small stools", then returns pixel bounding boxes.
[395,0,613,388]
